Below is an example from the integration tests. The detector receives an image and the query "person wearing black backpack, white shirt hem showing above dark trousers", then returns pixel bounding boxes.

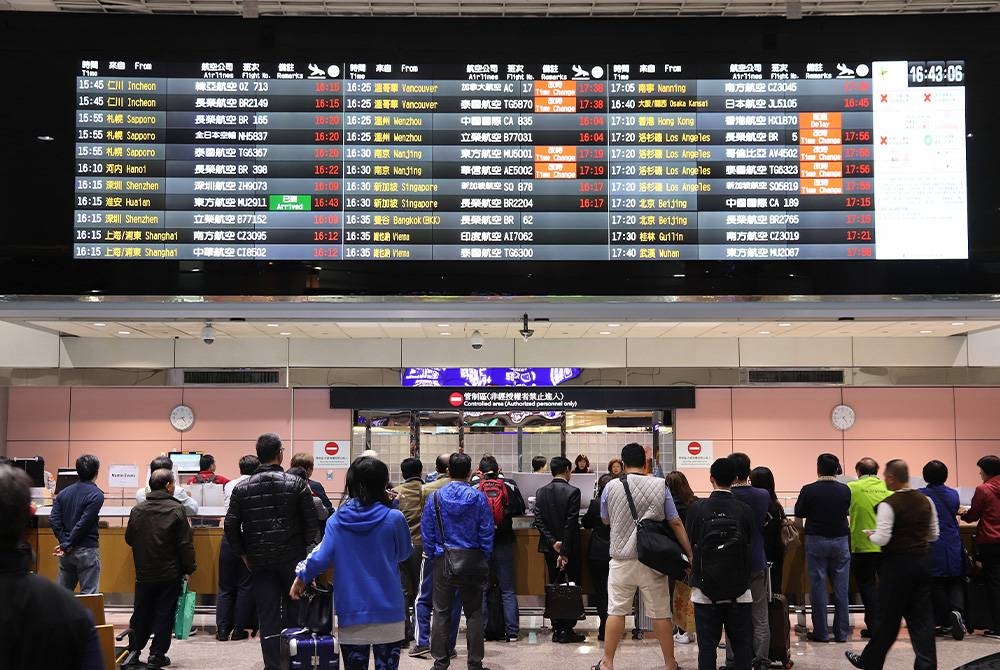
[685,458,755,670]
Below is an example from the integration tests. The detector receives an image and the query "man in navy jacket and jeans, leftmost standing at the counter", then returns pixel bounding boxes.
[49,454,104,593]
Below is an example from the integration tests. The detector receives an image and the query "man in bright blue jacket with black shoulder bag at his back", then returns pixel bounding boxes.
[420,453,495,670]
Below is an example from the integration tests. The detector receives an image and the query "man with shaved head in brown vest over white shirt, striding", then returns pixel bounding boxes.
[845,458,939,670]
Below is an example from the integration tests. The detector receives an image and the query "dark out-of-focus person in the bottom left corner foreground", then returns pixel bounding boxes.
[0,465,104,670]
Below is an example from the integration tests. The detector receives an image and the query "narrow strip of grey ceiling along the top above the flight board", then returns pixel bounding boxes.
[0,0,1000,19]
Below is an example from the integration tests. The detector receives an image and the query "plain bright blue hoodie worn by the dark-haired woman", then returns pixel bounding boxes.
[295,499,413,627]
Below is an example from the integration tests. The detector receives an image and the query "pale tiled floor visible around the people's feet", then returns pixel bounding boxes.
[109,611,1000,670]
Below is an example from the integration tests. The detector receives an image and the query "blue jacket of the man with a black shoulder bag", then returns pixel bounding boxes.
[420,480,496,558]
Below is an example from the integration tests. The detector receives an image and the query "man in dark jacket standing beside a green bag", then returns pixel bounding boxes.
[125,469,196,668]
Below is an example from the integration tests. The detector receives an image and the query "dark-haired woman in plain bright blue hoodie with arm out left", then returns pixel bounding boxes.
[291,456,413,670]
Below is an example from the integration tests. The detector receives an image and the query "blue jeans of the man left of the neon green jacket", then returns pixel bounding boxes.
[806,535,851,641]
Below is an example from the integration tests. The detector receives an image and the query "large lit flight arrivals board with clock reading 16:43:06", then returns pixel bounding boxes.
[73,60,969,262]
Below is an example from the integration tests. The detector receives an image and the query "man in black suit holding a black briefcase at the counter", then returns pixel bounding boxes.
[535,456,587,643]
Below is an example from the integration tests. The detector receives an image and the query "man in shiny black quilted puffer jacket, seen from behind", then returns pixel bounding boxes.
[226,433,319,670]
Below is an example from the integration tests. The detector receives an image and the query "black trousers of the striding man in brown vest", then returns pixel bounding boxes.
[861,554,937,670]
